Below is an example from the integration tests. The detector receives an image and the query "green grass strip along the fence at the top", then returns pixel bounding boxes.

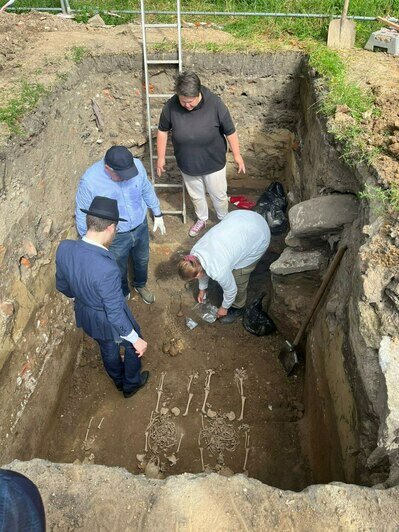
[11,0,398,46]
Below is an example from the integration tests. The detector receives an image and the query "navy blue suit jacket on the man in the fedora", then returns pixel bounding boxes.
[56,240,140,340]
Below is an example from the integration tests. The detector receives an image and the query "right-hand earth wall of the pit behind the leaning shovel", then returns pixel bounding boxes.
[282,64,399,484]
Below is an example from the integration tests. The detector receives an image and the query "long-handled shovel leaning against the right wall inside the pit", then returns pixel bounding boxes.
[278,246,348,375]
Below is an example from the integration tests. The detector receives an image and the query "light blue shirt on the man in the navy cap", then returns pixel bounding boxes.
[75,159,161,236]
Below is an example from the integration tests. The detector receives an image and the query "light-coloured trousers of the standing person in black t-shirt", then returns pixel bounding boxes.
[182,167,229,222]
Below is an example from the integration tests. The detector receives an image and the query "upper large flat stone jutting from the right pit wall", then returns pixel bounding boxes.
[288,194,358,238]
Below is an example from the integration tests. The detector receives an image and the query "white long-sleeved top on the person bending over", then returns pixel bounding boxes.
[191,210,270,309]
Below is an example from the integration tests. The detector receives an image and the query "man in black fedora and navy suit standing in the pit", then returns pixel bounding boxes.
[56,196,149,397]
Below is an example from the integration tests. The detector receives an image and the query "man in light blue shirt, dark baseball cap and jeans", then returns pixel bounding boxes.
[75,146,166,304]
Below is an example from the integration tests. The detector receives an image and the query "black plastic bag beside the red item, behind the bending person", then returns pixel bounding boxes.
[253,181,288,235]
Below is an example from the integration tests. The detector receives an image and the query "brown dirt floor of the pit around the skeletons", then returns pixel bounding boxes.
[38,189,311,490]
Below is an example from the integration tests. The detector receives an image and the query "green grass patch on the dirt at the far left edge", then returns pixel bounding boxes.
[0,81,46,134]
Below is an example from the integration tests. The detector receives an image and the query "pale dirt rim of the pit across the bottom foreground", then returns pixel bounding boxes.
[6,460,399,532]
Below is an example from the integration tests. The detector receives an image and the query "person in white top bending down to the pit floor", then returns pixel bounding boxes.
[178,210,270,323]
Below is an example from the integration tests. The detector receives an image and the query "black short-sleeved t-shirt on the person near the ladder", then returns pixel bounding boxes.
[158,87,235,175]
